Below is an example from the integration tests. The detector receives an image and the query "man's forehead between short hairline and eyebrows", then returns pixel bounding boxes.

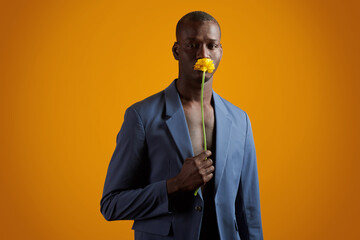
[177,21,221,41]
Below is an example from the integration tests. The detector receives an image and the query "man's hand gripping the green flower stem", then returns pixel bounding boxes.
[166,150,215,195]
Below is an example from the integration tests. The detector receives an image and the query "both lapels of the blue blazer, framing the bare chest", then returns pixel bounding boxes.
[164,79,232,195]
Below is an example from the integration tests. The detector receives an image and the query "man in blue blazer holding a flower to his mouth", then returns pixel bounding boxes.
[100,12,263,240]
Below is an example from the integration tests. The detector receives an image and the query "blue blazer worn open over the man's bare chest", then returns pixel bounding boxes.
[100,80,263,240]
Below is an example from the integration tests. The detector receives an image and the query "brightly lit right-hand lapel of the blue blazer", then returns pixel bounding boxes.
[213,90,232,195]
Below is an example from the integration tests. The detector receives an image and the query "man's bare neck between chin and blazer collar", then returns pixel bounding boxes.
[176,77,213,105]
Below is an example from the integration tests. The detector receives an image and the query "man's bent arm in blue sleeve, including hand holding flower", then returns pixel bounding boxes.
[100,107,215,221]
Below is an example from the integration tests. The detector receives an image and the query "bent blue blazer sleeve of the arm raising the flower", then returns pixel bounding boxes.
[100,107,169,221]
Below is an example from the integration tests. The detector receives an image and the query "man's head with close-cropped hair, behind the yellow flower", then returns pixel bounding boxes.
[172,11,222,83]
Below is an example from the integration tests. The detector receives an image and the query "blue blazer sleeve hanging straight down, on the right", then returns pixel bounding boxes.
[235,113,263,240]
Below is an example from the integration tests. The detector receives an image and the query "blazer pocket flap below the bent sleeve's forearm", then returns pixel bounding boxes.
[132,219,171,236]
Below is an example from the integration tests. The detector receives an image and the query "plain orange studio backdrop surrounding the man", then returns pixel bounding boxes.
[0,0,360,240]
